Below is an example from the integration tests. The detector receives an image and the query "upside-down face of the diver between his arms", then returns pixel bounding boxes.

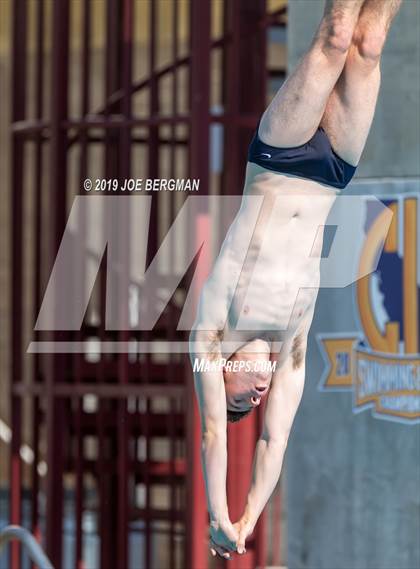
[223,354,272,411]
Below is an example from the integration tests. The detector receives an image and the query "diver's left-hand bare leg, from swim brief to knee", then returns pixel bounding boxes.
[258,0,363,147]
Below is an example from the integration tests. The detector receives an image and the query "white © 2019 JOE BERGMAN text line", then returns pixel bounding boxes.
[83,178,200,192]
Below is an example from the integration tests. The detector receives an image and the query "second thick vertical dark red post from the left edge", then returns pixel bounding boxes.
[46,0,69,566]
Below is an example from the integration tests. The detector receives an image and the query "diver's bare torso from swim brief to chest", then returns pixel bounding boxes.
[194,163,337,351]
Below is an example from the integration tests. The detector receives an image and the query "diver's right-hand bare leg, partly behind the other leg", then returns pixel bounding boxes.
[321,0,402,166]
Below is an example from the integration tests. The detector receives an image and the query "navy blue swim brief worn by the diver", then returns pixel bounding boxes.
[248,121,356,190]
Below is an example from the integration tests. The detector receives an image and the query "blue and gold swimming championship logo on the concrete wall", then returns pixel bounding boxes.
[318,194,420,424]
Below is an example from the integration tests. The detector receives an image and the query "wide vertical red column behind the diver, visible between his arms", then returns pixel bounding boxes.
[223,0,266,569]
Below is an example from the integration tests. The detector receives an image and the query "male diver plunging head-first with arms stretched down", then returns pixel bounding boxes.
[191,0,402,558]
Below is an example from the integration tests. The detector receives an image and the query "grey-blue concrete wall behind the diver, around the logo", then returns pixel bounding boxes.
[286,0,420,569]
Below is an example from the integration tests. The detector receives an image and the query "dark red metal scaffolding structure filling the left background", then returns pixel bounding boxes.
[10,0,285,569]
